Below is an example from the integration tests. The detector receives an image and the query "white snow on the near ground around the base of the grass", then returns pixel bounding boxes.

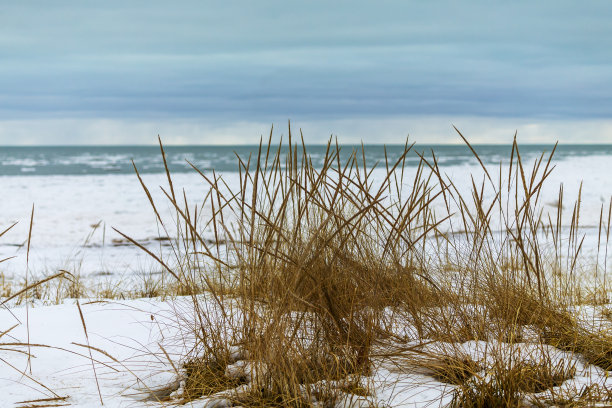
[0,298,612,408]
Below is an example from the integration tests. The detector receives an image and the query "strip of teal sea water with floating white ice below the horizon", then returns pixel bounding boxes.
[0,144,612,176]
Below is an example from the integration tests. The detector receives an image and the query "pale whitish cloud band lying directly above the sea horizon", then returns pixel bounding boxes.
[0,116,612,145]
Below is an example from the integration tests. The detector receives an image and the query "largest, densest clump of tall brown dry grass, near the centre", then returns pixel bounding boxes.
[126,131,441,406]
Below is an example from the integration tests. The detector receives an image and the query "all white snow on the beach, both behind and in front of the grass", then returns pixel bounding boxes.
[0,147,612,407]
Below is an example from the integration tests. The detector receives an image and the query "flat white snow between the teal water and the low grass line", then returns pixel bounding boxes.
[0,151,612,280]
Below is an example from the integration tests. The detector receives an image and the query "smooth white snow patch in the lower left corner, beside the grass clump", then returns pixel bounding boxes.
[0,300,180,407]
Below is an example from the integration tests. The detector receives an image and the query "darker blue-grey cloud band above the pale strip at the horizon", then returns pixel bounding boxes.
[0,46,612,121]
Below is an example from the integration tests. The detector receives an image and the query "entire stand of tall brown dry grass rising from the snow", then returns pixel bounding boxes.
[126,126,612,407]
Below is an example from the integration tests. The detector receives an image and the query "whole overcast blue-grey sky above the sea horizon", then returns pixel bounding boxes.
[0,0,612,145]
